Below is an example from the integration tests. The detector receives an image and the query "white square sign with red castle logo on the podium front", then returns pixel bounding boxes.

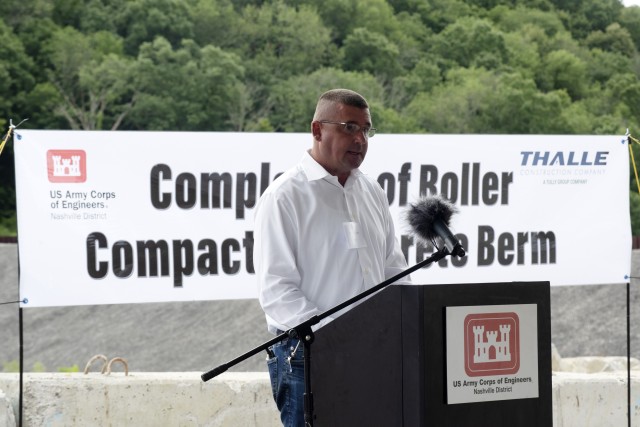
[445,304,540,404]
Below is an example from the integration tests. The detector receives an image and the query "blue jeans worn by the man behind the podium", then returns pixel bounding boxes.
[267,338,304,427]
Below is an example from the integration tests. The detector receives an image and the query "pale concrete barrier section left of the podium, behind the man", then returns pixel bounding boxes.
[0,372,279,427]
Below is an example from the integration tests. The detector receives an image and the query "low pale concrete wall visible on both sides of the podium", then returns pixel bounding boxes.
[0,371,640,427]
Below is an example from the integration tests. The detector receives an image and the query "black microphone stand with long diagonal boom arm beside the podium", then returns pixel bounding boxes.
[200,243,456,427]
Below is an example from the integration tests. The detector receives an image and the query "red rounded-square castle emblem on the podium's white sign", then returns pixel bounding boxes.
[464,312,520,377]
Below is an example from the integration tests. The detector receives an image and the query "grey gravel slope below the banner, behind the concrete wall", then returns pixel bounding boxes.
[0,243,640,372]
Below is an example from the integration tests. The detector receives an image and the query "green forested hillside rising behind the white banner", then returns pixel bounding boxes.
[0,0,640,235]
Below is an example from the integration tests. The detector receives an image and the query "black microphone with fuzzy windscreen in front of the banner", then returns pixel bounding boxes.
[406,196,466,258]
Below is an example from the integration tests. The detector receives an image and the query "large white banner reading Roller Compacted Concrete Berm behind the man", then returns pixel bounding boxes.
[15,130,631,307]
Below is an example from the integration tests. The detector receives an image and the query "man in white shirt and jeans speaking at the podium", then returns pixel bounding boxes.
[254,89,409,427]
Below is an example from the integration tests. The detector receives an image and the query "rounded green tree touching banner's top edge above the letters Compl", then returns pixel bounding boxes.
[126,37,243,130]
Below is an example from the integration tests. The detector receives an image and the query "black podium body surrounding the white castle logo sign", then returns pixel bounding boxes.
[311,282,553,427]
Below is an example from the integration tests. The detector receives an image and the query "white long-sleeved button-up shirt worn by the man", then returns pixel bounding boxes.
[253,153,410,333]
